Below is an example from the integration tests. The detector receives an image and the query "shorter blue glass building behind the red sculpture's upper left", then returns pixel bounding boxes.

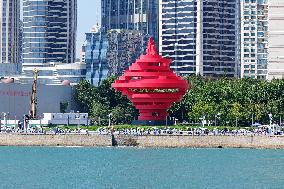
[84,25,143,86]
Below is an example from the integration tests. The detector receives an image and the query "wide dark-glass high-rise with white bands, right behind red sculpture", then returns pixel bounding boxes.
[159,0,239,77]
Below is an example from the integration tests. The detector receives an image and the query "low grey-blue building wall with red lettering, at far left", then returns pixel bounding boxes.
[0,83,76,118]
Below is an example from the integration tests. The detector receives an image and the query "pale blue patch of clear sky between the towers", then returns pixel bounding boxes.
[77,0,101,58]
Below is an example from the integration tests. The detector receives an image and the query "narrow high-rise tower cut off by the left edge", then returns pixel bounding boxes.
[0,0,20,63]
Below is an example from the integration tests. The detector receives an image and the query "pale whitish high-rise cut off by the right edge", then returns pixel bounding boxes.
[268,0,284,80]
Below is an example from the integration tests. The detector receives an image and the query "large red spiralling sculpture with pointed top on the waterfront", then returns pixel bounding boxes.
[112,38,189,125]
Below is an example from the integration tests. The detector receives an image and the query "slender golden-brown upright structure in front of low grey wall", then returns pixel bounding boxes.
[29,68,39,119]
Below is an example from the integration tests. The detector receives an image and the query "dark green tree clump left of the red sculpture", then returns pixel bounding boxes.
[75,76,138,125]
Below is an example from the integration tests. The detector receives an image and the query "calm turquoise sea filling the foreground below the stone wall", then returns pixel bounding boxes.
[0,147,284,189]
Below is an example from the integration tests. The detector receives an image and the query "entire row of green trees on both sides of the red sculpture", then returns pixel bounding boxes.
[75,76,284,126]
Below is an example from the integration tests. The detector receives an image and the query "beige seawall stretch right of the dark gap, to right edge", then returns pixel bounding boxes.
[112,135,284,149]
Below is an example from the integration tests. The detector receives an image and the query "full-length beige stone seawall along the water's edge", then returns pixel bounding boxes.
[0,134,284,149]
